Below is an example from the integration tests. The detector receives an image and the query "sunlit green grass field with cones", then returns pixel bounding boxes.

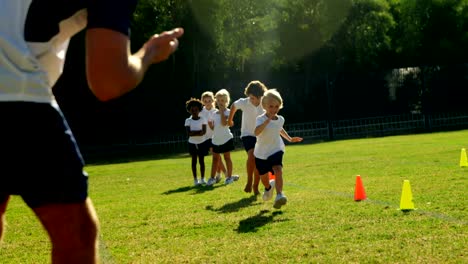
[0,130,468,263]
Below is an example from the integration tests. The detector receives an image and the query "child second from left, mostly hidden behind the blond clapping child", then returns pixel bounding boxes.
[200,91,226,184]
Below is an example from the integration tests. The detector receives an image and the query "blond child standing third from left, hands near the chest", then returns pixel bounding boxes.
[206,89,238,186]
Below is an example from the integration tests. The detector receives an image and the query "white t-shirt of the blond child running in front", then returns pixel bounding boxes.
[254,114,285,160]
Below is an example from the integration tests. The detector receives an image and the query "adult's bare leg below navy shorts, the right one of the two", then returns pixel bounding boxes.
[33,198,99,264]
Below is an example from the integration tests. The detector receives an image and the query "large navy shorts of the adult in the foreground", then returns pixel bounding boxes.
[0,102,88,208]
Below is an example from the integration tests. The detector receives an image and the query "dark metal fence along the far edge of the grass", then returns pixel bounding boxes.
[82,113,468,161]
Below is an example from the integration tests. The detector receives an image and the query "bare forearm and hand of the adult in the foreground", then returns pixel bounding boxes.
[86,28,184,101]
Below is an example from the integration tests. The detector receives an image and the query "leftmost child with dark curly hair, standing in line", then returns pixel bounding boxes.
[185,98,209,186]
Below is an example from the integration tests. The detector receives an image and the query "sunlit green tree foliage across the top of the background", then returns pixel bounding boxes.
[129,0,468,72]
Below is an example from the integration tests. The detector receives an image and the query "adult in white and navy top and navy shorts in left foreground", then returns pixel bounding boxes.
[0,0,183,263]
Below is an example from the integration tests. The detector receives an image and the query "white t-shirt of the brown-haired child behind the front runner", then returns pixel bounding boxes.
[233,97,265,137]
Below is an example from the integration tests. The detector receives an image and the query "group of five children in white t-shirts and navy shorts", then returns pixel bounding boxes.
[185,81,302,209]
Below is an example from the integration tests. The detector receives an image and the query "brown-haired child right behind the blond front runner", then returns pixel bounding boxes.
[228,81,267,195]
